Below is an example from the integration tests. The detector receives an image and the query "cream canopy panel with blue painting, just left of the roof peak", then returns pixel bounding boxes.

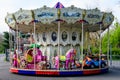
[33,6,57,24]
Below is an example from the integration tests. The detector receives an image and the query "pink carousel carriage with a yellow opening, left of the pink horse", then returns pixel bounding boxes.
[25,48,47,69]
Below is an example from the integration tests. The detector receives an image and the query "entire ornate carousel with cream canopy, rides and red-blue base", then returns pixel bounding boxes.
[5,2,114,76]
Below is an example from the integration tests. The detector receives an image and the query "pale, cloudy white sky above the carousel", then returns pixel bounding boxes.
[0,0,120,33]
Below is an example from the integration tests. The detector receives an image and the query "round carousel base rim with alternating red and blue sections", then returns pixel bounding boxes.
[10,67,109,76]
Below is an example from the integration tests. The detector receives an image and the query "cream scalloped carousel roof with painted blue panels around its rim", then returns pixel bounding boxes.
[5,6,114,32]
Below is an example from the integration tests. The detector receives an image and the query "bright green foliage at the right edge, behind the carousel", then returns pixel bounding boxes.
[102,22,120,55]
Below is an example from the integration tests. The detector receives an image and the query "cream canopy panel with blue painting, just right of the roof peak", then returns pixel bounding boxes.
[61,6,84,23]
